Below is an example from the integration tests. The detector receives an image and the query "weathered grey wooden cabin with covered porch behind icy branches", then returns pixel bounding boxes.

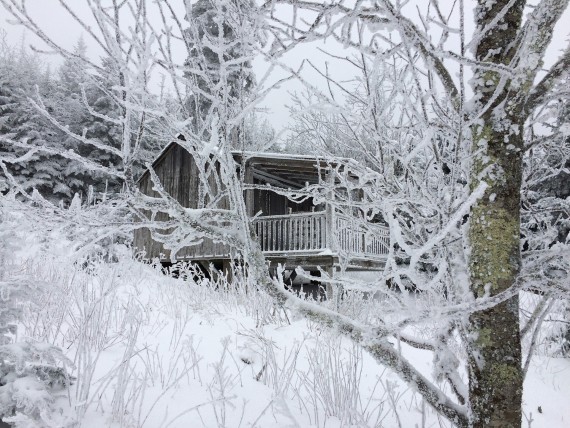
[134,143,389,280]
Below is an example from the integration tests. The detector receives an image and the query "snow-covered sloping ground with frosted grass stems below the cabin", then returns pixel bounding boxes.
[5,212,570,428]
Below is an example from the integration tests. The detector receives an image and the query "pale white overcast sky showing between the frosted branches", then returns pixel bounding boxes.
[0,0,570,134]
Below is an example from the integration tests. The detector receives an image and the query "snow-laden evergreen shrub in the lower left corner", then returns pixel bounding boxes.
[0,207,70,427]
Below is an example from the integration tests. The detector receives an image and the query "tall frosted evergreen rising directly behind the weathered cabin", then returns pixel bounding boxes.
[184,0,259,148]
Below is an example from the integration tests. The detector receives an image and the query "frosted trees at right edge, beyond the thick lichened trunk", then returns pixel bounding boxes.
[521,75,570,355]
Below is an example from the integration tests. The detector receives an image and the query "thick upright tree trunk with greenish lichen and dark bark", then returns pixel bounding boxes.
[469,0,524,428]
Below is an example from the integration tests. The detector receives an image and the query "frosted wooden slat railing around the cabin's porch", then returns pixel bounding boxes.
[254,211,390,258]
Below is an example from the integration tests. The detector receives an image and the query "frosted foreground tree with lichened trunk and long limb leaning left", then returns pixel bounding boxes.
[0,0,570,427]
